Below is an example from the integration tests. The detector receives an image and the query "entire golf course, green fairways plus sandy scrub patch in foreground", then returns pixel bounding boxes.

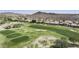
[0,22,79,48]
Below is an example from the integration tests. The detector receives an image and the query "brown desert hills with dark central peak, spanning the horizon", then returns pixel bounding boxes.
[0,11,79,21]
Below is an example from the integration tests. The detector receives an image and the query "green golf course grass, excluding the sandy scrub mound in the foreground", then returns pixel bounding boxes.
[0,23,79,48]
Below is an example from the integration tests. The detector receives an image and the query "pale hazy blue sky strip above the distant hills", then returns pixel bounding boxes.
[0,10,79,14]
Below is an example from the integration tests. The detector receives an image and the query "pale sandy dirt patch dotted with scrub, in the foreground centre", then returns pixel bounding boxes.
[29,35,58,48]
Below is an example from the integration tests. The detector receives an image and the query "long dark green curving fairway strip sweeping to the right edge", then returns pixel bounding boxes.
[30,25,79,42]
